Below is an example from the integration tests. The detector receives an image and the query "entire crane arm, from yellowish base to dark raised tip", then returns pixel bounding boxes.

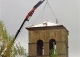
[2,0,45,57]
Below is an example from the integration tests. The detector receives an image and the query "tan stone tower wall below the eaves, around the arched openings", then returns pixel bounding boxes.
[29,28,68,57]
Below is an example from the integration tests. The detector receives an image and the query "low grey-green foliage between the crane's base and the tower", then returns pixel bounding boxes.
[11,43,27,57]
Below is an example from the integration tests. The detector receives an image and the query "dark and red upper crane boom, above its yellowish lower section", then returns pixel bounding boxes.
[14,0,45,41]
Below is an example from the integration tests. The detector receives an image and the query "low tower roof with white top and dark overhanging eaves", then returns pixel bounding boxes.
[26,22,68,32]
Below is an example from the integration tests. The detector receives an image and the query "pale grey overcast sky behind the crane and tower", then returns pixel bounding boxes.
[0,0,80,57]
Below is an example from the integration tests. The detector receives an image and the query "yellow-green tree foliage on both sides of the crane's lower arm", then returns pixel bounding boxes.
[0,20,27,57]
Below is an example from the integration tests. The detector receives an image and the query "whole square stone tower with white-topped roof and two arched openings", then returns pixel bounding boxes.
[26,22,68,57]
